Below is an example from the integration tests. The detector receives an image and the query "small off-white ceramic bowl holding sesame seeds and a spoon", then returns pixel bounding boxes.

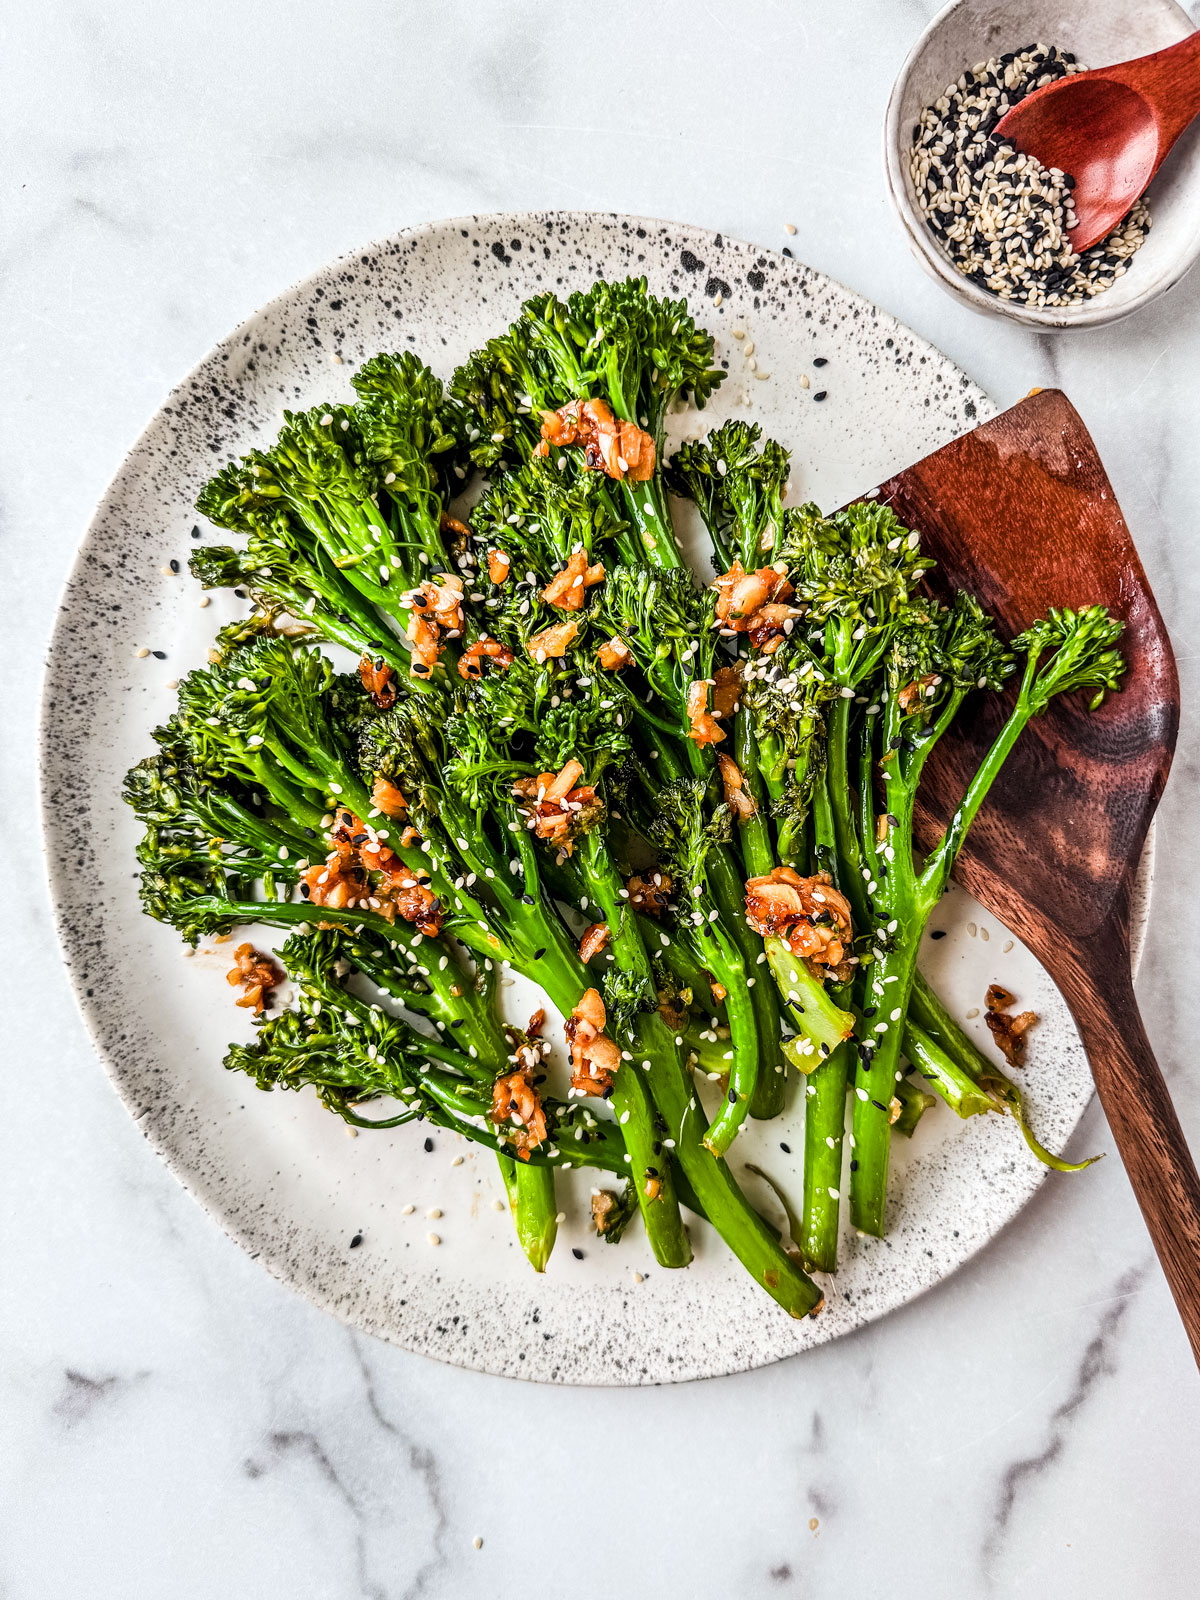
[883,0,1200,328]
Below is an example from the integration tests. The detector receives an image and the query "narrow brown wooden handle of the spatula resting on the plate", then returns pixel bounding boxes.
[1059,965,1200,1365]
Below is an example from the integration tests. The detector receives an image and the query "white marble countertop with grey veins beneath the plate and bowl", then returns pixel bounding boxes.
[9,0,1200,1600]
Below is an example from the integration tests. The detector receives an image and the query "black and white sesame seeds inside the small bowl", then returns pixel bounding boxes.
[910,45,1150,306]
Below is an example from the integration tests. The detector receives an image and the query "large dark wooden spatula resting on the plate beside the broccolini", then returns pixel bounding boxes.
[880,389,1200,1363]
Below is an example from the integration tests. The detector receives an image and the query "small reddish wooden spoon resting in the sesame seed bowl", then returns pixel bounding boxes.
[995,32,1200,254]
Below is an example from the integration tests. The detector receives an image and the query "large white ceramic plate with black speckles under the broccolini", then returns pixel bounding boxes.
[43,213,1145,1384]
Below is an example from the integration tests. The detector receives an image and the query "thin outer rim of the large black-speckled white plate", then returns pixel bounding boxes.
[35,208,1154,1387]
